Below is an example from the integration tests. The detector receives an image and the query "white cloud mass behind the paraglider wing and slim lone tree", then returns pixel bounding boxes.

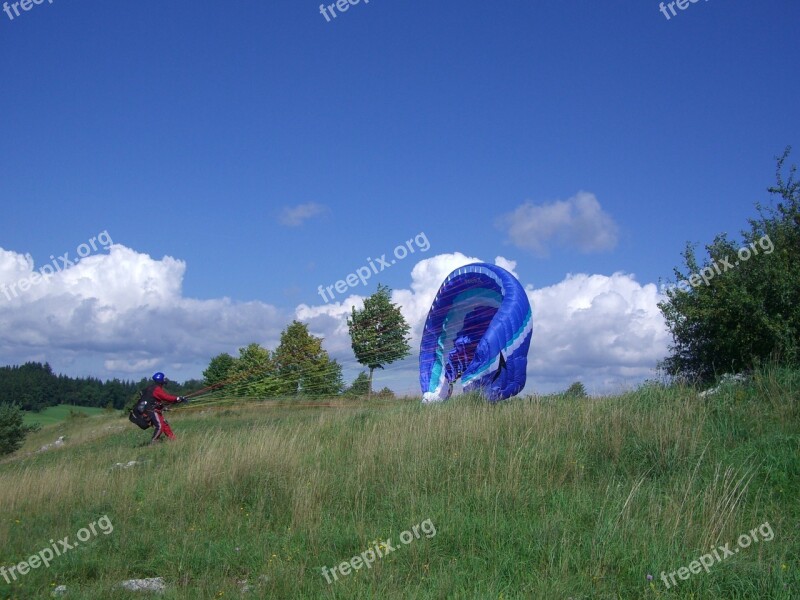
[296,253,669,394]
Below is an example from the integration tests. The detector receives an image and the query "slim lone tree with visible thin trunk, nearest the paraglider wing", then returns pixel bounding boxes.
[347,285,411,394]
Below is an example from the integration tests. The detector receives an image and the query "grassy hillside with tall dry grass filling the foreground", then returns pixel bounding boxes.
[0,370,800,600]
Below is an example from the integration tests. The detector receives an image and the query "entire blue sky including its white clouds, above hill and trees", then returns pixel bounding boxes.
[0,0,800,392]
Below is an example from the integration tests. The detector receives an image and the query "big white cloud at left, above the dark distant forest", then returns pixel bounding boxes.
[0,244,290,378]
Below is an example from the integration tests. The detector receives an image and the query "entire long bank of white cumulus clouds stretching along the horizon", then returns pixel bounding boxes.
[0,244,669,393]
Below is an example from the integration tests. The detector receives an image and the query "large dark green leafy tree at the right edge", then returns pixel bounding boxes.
[659,148,800,382]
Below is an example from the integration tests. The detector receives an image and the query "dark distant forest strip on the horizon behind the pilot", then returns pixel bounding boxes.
[0,362,203,411]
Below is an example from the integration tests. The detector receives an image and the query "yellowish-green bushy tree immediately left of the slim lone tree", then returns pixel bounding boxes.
[273,321,343,396]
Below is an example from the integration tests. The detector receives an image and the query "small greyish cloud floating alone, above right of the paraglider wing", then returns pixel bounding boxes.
[497,192,618,257]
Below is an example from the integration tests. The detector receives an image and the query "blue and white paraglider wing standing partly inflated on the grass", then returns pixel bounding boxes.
[419,263,533,403]
